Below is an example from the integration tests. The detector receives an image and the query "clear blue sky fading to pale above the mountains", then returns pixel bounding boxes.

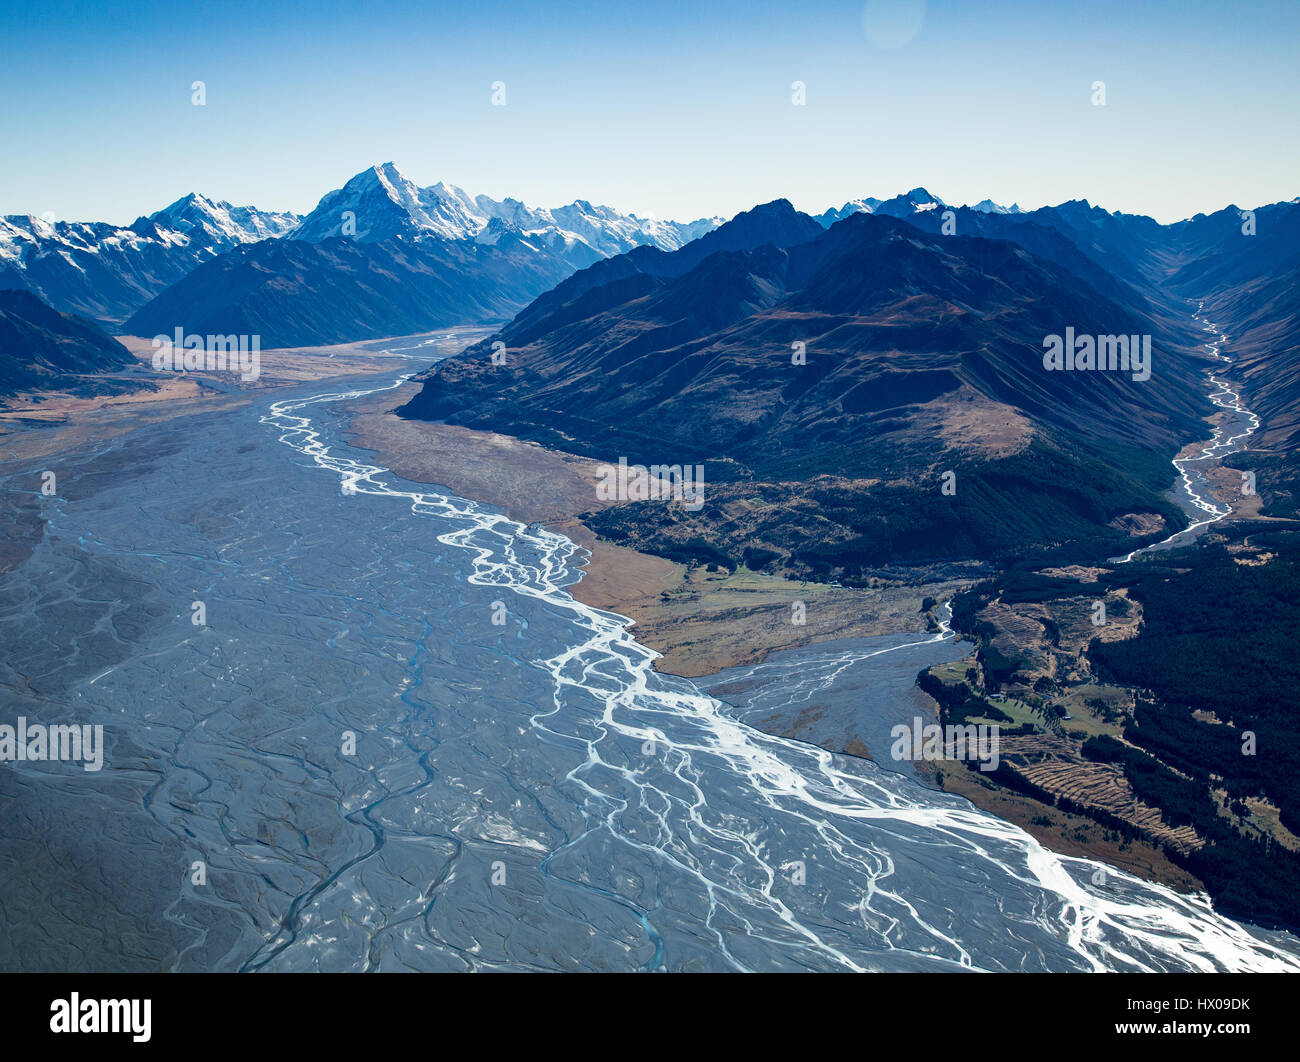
[0,0,1300,222]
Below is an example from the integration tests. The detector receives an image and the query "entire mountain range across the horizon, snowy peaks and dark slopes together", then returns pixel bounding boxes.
[0,170,1300,543]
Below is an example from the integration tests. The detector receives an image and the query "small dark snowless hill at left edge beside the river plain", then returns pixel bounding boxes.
[0,290,135,394]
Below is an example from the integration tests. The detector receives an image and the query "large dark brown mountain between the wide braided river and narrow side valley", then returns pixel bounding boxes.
[399,188,1300,582]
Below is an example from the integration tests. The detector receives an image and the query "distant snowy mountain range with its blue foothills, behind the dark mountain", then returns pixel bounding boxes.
[0,162,1060,346]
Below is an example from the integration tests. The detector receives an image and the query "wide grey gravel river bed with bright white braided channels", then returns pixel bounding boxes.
[0,363,1300,971]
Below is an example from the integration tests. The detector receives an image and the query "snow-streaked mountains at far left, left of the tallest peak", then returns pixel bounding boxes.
[0,195,299,322]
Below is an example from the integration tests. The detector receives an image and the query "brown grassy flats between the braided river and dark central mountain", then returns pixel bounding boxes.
[348,383,967,681]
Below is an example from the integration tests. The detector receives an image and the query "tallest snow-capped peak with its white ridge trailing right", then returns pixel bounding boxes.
[291,162,723,264]
